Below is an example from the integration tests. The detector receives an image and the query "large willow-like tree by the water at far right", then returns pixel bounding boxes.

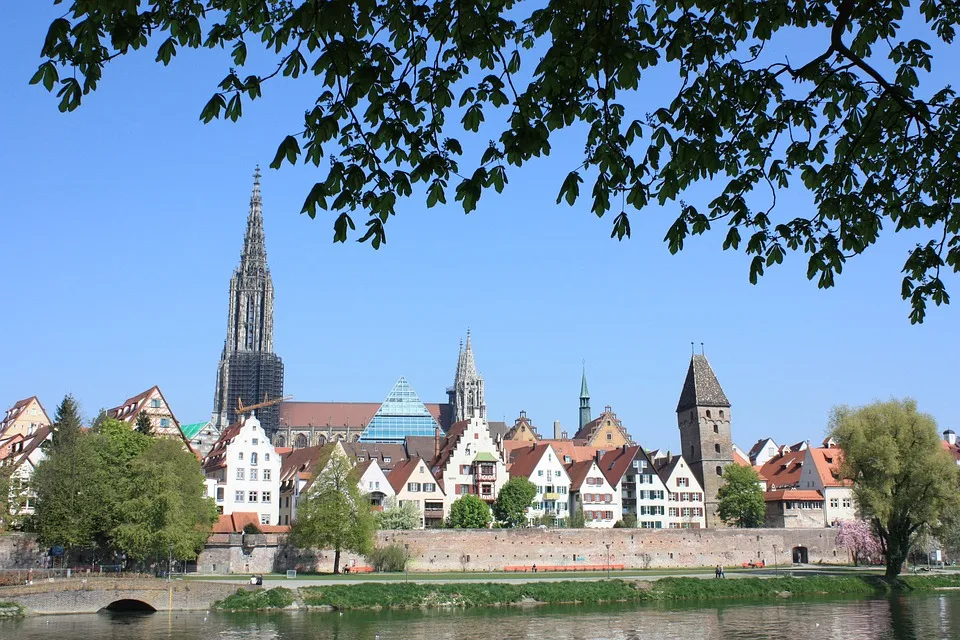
[830,400,960,577]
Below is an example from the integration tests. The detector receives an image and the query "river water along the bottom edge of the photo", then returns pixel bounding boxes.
[0,592,960,640]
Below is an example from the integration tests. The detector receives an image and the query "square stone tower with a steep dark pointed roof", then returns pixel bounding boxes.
[677,354,733,527]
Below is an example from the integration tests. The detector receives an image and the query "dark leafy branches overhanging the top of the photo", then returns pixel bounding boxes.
[31,0,960,322]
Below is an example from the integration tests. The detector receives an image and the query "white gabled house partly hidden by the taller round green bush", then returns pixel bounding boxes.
[509,443,570,524]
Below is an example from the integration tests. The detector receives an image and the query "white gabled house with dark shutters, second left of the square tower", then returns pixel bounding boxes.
[599,445,669,529]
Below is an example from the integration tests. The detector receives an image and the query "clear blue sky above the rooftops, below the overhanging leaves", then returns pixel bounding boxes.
[0,3,960,448]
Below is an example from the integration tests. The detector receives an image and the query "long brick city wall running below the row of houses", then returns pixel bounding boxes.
[197,529,849,574]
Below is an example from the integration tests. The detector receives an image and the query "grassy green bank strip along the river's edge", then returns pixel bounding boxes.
[216,575,960,611]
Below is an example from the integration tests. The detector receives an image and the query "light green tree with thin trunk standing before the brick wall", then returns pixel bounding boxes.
[290,454,375,574]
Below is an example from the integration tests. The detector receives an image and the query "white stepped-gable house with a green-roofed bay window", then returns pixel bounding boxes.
[429,418,507,503]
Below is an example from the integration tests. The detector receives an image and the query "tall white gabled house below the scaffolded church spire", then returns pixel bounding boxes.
[203,417,280,525]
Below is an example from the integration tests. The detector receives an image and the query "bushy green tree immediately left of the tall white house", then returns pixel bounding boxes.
[112,438,217,563]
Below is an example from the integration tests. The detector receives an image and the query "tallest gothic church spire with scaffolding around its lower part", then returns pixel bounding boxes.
[212,167,283,434]
